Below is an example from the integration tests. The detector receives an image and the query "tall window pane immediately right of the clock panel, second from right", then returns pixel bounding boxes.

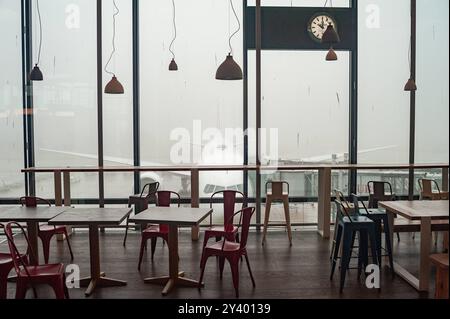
[358,0,411,195]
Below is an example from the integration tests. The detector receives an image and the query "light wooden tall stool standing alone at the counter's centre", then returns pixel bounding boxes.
[262,181,292,246]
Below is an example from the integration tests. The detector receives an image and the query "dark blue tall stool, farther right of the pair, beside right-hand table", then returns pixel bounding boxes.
[352,194,395,275]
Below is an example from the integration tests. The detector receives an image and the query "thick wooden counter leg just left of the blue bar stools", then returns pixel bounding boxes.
[318,168,331,239]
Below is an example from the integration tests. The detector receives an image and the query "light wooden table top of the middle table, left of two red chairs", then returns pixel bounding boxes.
[130,207,213,226]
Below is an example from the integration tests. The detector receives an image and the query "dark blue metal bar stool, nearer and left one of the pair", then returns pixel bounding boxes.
[330,200,378,292]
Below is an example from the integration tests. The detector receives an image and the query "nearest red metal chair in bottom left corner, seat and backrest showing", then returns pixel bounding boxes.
[5,222,69,299]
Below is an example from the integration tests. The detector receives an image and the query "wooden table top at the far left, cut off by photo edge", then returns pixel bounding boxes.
[0,206,71,222]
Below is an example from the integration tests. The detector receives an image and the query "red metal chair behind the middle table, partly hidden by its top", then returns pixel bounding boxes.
[138,191,181,270]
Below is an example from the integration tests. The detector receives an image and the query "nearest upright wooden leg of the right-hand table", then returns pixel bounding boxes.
[419,217,432,291]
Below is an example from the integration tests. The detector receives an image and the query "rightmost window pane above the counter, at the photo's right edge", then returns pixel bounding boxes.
[416,0,449,163]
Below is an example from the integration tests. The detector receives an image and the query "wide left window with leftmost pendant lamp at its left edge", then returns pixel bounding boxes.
[33,0,98,198]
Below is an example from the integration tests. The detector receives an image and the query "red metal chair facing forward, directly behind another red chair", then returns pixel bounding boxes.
[203,190,246,248]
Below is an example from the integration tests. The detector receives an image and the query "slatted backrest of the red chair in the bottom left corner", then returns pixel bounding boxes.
[4,222,36,276]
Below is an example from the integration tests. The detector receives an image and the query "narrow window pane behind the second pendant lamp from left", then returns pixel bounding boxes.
[102,0,134,198]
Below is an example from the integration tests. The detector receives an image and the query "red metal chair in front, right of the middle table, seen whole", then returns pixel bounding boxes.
[198,207,255,298]
